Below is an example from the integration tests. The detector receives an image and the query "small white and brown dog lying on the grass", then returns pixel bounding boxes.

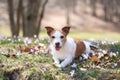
[45,26,91,67]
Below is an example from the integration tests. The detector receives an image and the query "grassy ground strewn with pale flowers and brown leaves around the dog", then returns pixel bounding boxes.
[0,37,120,80]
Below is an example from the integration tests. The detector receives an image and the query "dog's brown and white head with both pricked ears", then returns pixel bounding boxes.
[45,26,70,51]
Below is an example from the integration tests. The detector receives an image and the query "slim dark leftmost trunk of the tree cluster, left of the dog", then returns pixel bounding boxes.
[7,0,19,36]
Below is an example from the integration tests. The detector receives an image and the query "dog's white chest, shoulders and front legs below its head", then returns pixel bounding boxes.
[50,38,76,67]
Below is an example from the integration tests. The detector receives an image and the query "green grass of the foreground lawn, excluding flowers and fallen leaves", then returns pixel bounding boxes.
[0,38,120,80]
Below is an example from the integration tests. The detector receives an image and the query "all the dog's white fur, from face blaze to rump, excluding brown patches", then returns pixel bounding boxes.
[45,26,90,67]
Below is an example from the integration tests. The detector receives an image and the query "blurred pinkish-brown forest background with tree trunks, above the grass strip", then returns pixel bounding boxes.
[0,0,120,37]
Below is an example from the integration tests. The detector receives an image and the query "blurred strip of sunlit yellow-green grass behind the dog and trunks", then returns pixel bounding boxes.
[0,26,120,41]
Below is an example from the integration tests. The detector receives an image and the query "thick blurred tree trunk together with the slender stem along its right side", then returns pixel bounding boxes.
[22,0,48,37]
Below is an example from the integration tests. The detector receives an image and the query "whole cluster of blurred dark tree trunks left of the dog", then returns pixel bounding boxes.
[7,0,48,37]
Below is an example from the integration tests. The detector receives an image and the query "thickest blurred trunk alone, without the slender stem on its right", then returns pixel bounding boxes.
[23,0,41,37]
